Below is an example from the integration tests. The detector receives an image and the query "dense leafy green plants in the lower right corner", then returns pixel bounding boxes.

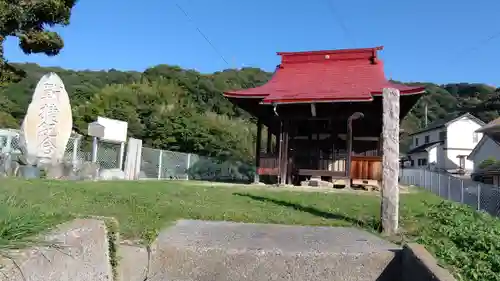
[417,202,500,281]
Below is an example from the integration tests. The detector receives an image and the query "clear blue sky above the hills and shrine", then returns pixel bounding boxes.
[5,0,500,86]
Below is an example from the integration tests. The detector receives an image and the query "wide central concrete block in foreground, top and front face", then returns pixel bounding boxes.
[148,220,400,281]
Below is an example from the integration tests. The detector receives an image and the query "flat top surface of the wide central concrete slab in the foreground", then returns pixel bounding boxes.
[157,220,400,254]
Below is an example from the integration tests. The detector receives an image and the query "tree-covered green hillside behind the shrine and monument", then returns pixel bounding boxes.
[0,64,500,161]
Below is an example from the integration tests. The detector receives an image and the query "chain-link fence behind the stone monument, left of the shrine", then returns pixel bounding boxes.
[0,127,256,182]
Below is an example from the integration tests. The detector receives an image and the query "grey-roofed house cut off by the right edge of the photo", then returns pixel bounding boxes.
[467,118,500,172]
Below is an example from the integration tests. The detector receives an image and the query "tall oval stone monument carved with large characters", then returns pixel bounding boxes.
[20,73,73,166]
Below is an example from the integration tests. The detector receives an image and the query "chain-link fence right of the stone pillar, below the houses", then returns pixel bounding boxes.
[399,169,500,216]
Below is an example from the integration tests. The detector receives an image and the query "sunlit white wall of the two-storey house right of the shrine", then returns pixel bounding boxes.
[448,116,483,171]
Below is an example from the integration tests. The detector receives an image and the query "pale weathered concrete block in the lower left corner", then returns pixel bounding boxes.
[0,219,113,281]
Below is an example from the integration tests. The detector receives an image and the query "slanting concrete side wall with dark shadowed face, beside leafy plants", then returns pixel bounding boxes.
[400,244,456,281]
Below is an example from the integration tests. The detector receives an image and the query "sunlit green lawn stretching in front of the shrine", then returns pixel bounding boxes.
[0,179,438,245]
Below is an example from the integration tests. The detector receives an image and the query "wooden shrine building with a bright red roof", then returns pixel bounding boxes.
[224,47,425,185]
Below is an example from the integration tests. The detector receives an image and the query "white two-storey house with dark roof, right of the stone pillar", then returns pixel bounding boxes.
[407,113,484,172]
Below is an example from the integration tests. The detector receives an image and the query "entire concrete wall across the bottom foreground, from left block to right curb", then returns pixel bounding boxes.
[0,218,455,281]
